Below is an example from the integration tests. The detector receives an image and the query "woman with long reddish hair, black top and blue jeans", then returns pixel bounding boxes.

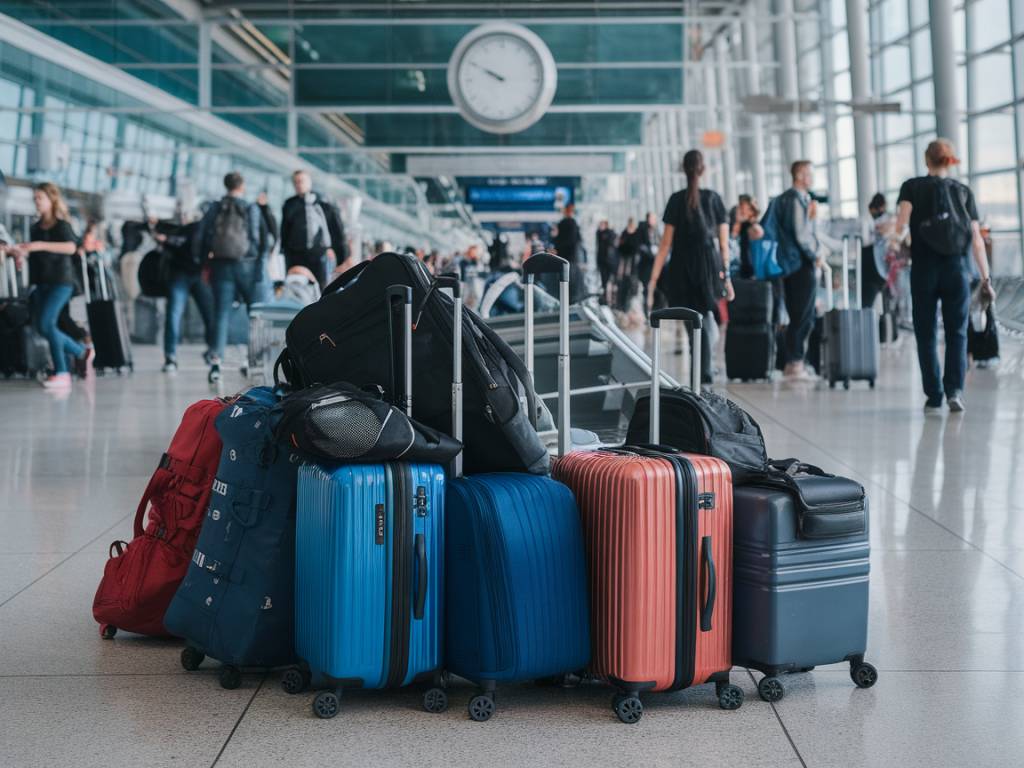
[13,181,94,390]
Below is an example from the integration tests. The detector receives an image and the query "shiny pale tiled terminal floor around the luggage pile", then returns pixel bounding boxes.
[0,340,1024,768]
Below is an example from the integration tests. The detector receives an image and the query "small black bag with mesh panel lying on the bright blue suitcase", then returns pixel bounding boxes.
[274,382,462,465]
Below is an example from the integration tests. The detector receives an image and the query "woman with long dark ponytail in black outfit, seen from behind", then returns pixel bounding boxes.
[647,150,735,384]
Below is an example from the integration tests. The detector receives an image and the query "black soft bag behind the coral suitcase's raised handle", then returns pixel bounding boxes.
[626,388,768,485]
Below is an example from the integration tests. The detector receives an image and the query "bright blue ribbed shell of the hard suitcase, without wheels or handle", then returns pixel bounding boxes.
[295,463,444,688]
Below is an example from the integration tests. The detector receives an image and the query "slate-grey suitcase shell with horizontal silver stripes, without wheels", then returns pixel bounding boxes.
[732,487,870,675]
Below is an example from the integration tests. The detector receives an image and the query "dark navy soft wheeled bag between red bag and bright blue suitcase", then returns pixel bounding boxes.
[164,387,298,688]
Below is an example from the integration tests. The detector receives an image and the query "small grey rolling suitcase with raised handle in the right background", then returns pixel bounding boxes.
[821,237,879,389]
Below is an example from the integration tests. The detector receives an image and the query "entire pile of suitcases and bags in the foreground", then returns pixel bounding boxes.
[93,254,877,723]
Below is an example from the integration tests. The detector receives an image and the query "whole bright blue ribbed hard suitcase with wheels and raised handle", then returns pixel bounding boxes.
[290,286,446,719]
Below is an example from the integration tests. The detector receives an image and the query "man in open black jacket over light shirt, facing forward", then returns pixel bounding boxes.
[281,170,348,288]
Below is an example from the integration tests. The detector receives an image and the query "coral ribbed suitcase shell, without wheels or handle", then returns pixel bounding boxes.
[554,449,732,690]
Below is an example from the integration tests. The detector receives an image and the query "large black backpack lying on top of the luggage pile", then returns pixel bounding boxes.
[275,253,550,474]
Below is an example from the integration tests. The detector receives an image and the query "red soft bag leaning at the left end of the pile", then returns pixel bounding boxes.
[92,400,225,639]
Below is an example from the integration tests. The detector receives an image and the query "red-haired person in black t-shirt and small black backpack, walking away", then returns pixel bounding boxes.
[895,138,995,413]
